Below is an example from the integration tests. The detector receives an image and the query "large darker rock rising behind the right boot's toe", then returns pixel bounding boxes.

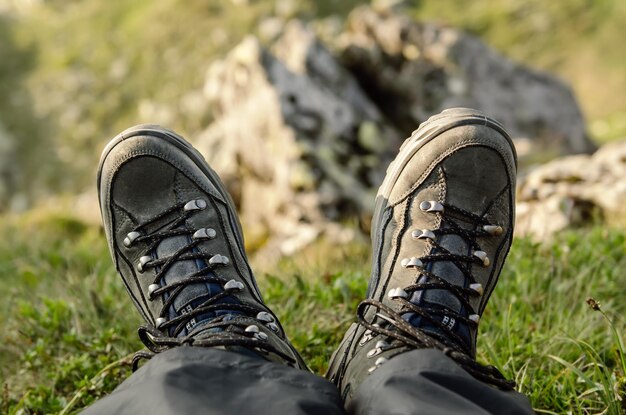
[336,7,594,157]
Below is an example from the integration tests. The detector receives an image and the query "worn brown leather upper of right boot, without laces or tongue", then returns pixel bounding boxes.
[327,109,516,402]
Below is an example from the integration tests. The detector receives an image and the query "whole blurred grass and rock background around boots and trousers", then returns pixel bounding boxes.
[0,0,626,414]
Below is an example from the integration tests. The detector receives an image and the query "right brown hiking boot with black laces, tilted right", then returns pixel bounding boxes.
[327,108,517,402]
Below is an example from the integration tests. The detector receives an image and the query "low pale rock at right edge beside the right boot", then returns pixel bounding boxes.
[516,140,626,239]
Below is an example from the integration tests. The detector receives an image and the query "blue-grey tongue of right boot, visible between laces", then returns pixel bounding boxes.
[402,228,471,350]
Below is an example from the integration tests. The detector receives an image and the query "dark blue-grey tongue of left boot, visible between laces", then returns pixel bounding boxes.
[155,229,238,337]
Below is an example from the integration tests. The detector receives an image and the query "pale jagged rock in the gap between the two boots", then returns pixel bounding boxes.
[194,27,400,254]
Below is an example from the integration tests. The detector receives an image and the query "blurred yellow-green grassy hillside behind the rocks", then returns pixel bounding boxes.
[0,0,626,212]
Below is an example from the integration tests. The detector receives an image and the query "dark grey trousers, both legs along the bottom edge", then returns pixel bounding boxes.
[83,347,534,415]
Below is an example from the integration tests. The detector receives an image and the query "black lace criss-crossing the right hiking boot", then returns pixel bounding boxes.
[357,201,515,390]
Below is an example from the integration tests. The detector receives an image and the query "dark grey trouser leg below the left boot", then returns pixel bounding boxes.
[84,347,345,415]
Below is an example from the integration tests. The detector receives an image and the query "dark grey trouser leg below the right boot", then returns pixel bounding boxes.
[346,349,534,415]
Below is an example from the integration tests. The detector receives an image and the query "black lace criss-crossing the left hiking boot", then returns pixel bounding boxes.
[124,199,295,371]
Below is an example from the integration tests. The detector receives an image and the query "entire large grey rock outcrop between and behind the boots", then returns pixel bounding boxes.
[194,8,593,256]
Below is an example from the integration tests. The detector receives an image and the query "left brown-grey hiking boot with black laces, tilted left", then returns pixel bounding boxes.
[98,125,306,369]
